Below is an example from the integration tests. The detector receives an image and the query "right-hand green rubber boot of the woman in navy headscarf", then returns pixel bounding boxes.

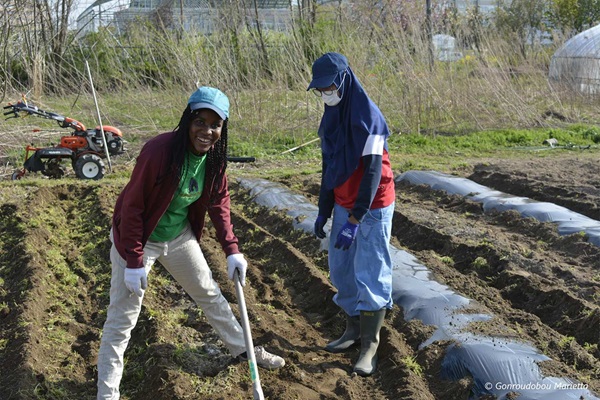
[354,308,385,376]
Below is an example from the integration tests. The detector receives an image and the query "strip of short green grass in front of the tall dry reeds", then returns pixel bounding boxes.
[0,90,600,184]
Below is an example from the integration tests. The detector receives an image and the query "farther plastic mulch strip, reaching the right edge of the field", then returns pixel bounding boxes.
[396,171,600,246]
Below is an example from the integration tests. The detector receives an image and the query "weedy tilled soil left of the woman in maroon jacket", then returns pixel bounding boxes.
[0,184,138,399]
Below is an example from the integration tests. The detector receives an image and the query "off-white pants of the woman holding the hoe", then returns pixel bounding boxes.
[97,226,246,400]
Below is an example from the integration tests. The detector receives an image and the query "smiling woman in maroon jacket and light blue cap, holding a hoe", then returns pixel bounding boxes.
[97,87,285,400]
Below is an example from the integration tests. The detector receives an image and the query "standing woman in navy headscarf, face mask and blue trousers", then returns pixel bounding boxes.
[307,53,396,376]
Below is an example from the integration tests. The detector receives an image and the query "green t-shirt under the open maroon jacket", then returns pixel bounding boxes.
[149,151,206,242]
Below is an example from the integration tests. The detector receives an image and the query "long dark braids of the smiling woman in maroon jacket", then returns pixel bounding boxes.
[170,105,229,203]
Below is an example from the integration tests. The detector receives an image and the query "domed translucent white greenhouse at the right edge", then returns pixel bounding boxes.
[548,25,600,95]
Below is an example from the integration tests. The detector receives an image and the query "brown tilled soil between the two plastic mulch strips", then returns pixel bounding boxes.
[393,187,600,390]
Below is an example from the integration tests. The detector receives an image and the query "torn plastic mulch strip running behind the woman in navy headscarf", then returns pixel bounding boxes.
[239,179,600,400]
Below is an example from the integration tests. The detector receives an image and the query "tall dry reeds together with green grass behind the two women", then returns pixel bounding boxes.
[0,2,600,186]
